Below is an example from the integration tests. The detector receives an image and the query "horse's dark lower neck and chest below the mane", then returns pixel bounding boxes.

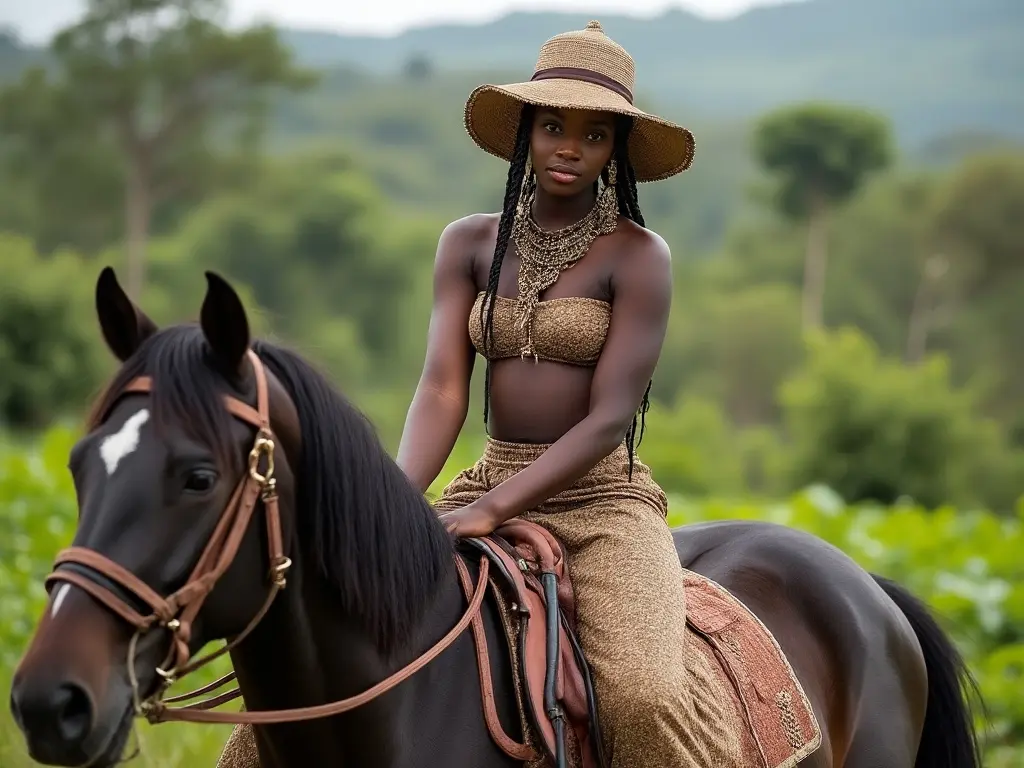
[231,553,474,768]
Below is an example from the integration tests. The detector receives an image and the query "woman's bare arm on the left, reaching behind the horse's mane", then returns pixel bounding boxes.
[397,216,484,492]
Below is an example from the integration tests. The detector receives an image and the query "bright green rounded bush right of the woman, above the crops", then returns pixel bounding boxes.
[780,329,1016,508]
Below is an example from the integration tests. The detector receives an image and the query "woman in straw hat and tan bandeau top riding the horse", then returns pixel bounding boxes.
[398,22,741,768]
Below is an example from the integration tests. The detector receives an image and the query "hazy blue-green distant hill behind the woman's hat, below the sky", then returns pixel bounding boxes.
[276,0,1024,142]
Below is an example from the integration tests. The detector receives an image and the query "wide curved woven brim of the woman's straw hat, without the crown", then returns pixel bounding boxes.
[465,79,694,181]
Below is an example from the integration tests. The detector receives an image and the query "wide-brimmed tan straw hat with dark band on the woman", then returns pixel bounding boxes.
[465,22,693,181]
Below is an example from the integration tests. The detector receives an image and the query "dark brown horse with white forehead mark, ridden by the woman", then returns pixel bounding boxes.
[11,270,980,768]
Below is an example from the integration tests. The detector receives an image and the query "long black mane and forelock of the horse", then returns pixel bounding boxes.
[90,325,453,653]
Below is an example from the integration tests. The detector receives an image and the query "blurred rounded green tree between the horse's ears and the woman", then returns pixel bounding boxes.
[163,152,443,386]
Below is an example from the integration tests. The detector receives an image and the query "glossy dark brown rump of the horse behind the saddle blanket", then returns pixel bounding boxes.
[673,520,927,768]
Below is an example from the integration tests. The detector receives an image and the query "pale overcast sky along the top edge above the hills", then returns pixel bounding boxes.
[0,0,798,42]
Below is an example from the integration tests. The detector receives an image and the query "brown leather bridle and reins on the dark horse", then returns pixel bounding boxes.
[45,349,493,729]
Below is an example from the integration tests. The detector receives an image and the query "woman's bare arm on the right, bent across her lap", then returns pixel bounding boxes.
[456,230,672,526]
